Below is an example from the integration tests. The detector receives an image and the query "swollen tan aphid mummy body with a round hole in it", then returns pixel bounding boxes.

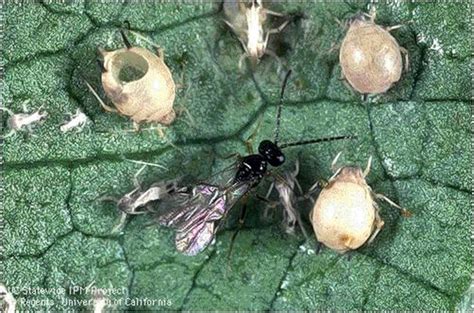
[102,47,176,125]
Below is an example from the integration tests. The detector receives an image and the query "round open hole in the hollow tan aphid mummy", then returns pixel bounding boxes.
[112,51,148,83]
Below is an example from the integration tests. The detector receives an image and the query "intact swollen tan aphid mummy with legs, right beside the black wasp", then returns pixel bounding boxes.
[310,153,411,253]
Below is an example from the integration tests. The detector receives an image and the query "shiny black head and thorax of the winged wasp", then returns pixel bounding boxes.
[234,140,285,185]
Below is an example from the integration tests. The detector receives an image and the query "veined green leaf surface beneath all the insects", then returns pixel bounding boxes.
[0,1,472,311]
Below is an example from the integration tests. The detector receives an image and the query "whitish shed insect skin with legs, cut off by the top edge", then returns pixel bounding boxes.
[224,0,290,68]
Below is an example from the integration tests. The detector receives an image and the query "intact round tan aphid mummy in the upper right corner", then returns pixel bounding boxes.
[339,7,408,94]
